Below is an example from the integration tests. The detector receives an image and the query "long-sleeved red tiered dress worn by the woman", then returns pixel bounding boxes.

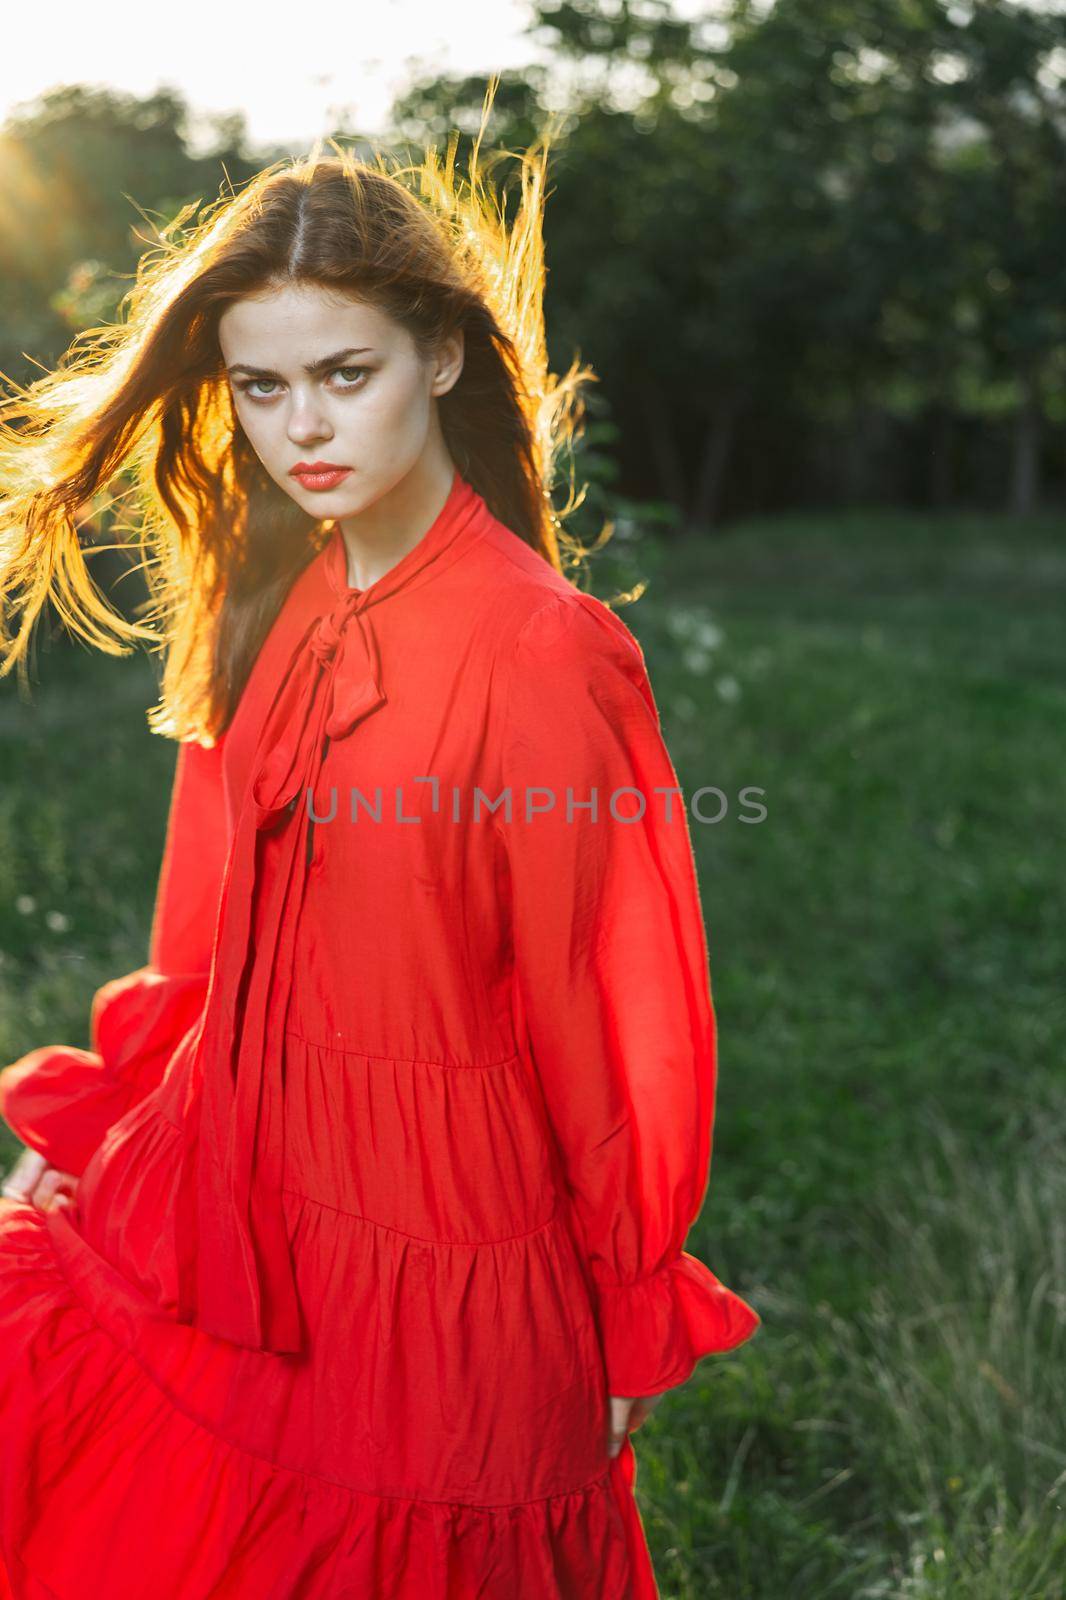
[0,474,759,1600]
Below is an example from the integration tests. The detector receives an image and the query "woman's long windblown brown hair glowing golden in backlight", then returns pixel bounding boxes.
[0,80,595,744]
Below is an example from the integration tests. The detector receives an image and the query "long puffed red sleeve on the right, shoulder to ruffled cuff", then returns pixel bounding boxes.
[496,590,760,1397]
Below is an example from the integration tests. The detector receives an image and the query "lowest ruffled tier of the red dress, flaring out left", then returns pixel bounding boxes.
[0,1200,656,1600]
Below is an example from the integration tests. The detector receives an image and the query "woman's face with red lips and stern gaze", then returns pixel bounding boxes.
[219,283,463,520]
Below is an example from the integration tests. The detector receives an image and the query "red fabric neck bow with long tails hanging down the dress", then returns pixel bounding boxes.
[176,590,386,1352]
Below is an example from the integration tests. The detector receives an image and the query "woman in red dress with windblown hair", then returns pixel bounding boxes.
[0,103,759,1600]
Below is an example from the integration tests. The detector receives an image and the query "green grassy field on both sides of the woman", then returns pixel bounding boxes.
[0,512,1066,1600]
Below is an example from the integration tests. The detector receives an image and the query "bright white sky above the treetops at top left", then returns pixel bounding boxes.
[0,0,715,146]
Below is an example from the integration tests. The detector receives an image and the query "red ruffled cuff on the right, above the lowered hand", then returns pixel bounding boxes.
[595,1251,762,1397]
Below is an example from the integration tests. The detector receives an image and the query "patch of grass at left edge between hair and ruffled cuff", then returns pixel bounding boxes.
[0,630,176,1056]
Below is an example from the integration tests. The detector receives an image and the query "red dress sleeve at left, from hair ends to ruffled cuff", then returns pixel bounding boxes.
[0,741,227,1176]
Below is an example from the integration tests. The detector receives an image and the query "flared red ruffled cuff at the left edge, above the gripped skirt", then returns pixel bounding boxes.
[0,966,208,1176]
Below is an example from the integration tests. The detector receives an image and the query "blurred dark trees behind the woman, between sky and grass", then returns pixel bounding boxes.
[0,0,1066,534]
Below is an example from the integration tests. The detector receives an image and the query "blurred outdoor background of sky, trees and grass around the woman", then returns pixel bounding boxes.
[0,0,1066,1600]
